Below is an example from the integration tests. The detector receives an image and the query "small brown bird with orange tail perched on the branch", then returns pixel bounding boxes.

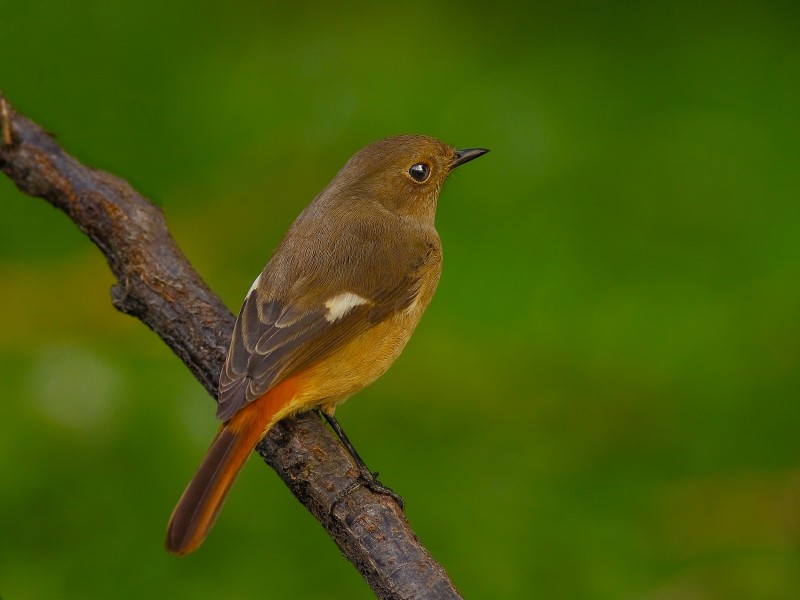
[167,135,488,554]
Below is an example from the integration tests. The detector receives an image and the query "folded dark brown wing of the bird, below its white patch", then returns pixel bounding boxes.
[217,271,420,421]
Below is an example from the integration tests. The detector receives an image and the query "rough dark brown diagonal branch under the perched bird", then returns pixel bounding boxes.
[0,93,460,599]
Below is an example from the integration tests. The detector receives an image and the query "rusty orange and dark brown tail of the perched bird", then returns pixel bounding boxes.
[166,380,296,555]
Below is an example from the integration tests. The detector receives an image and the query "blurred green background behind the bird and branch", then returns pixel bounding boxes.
[0,0,800,600]
